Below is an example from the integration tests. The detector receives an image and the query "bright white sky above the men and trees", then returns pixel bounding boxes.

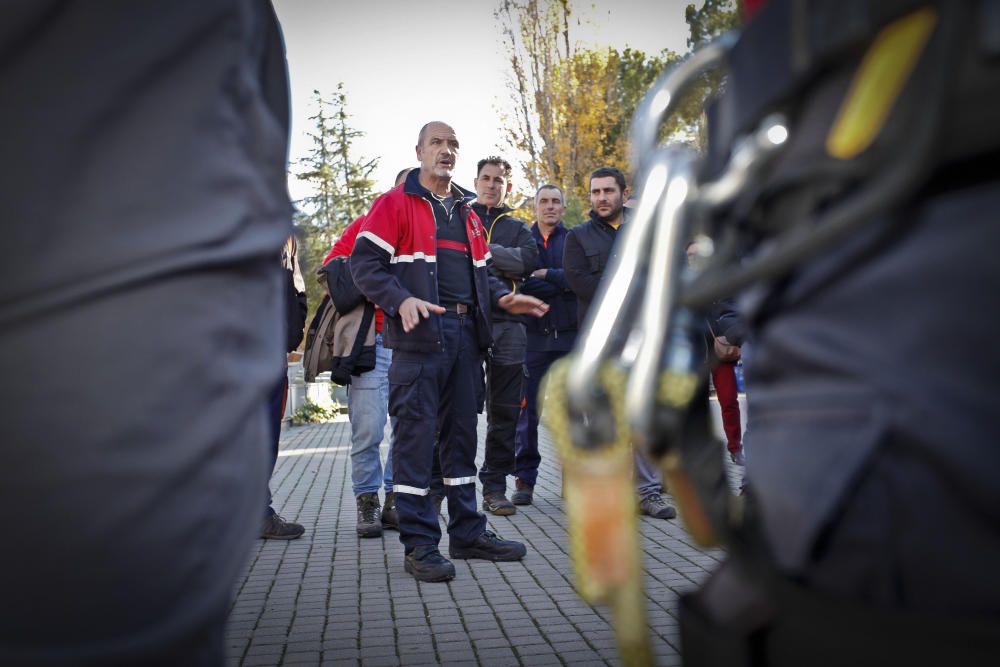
[274,0,697,204]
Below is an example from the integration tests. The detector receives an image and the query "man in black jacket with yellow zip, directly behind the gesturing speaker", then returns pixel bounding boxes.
[472,156,538,516]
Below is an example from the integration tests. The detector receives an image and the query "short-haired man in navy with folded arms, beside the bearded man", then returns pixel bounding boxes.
[511,185,577,505]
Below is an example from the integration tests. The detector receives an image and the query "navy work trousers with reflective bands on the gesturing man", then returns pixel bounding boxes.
[389,313,486,552]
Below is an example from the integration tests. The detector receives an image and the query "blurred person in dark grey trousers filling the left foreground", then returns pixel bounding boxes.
[0,0,292,665]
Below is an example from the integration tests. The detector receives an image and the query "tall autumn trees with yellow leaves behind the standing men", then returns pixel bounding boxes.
[496,0,678,224]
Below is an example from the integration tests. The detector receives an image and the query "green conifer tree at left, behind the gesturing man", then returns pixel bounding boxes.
[295,83,378,326]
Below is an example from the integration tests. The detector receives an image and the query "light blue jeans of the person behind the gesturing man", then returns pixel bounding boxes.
[347,333,396,497]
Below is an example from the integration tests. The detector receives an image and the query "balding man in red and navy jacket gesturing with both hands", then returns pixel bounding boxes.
[351,122,548,581]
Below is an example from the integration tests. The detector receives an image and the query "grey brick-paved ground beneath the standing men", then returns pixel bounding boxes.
[227,408,744,667]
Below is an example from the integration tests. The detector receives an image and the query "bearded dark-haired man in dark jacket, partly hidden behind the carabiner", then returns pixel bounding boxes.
[563,167,677,519]
